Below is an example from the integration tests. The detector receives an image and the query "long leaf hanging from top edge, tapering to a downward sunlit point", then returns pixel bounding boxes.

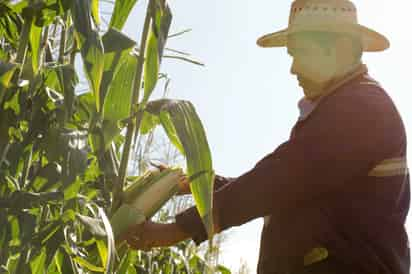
[72,0,104,112]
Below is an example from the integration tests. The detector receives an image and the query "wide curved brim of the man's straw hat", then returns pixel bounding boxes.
[257,24,390,51]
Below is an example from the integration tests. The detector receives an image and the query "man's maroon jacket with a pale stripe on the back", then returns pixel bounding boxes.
[176,73,410,274]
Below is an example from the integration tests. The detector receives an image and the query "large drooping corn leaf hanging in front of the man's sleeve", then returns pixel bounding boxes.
[146,99,214,238]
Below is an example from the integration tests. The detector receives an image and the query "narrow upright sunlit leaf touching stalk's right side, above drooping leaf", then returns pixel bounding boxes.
[143,30,159,104]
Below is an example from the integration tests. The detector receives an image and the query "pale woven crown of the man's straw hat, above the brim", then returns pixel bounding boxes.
[289,0,358,27]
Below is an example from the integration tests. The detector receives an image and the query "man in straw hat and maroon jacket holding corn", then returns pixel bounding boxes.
[120,0,410,274]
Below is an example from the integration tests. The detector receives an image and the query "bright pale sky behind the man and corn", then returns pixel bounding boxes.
[125,0,412,273]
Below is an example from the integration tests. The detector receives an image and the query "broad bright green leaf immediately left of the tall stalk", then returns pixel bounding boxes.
[103,52,137,149]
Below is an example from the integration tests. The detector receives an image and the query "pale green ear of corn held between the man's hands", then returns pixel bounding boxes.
[111,168,182,237]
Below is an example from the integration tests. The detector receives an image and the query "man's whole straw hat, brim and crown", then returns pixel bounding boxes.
[257,0,389,51]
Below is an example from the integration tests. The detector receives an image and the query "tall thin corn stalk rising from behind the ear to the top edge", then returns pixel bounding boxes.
[112,0,153,213]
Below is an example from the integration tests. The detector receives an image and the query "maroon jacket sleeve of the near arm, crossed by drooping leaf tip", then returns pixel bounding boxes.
[176,85,403,243]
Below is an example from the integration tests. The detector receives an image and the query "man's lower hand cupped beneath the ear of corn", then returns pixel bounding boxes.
[117,221,190,251]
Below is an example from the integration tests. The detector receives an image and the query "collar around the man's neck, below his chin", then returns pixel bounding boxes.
[298,64,368,121]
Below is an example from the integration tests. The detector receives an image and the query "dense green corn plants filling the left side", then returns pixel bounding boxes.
[0,0,224,274]
